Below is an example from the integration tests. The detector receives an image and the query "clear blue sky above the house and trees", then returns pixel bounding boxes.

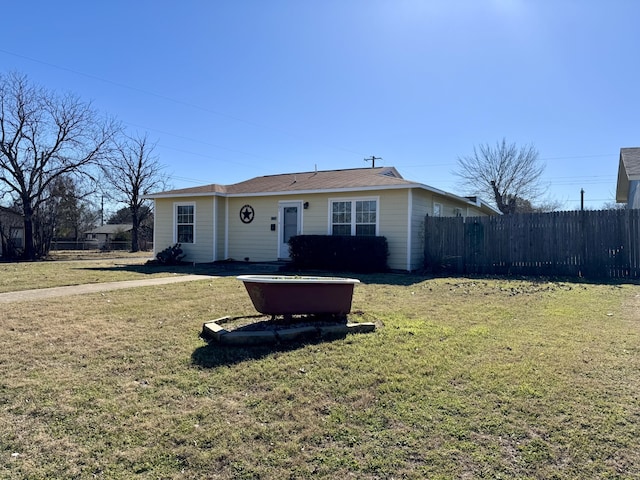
[0,0,640,209]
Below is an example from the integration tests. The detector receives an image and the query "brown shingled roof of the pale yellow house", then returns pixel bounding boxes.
[150,167,416,197]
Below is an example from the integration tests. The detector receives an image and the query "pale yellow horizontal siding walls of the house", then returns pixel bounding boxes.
[154,184,496,270]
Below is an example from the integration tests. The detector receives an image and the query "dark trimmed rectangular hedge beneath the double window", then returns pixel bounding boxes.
[289,235,389,273]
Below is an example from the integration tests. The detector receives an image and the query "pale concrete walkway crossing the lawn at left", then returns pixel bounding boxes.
[0,275,218,304]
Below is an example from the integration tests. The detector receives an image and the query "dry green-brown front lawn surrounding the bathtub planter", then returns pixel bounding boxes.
[0,264,640,479]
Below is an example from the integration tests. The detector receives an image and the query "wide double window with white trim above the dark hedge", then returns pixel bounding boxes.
[331,199,378,236]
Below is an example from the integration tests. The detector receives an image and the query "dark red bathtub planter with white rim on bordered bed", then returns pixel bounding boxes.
[202,275,375,345]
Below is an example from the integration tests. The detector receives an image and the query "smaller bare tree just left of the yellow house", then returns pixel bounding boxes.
[102,134,168,252]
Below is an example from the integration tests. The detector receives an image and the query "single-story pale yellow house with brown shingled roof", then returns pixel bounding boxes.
[147,167,499,271]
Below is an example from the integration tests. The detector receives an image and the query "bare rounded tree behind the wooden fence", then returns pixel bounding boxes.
[454,138,545,214]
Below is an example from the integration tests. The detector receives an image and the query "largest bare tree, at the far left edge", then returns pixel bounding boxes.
[0,73,118,259]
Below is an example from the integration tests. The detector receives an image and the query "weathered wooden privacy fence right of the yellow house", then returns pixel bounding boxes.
[424,210,640,278]
